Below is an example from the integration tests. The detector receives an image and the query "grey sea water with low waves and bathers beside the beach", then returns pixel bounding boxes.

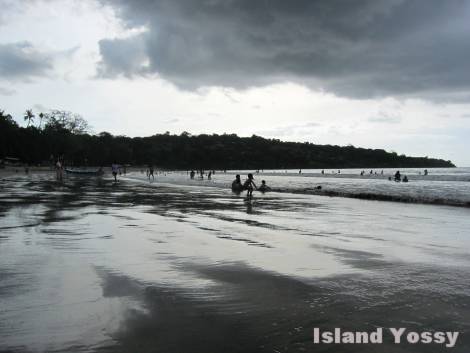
[132,168,470,207]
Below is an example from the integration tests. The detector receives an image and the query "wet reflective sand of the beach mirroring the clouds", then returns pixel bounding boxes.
[0,173,470,352]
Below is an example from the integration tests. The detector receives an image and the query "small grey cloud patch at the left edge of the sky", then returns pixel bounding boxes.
[0,42,52,80]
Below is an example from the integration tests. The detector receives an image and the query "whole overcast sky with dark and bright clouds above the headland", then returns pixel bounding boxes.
[0,0,470,166]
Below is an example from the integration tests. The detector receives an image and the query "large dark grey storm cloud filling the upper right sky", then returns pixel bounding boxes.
[99,0,470,97]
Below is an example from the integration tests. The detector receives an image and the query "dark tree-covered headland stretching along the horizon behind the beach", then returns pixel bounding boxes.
[0,110,454,169]
